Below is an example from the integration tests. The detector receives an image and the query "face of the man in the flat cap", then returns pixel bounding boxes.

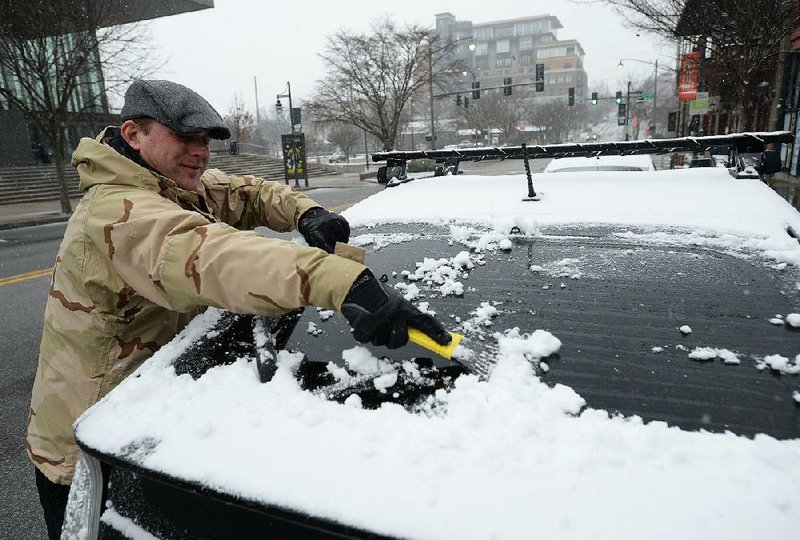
[120,120,211,191]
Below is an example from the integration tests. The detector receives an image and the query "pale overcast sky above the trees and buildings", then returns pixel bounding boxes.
[145,0,675,114]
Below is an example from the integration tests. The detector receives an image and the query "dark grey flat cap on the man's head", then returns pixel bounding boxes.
[120,80,231,139]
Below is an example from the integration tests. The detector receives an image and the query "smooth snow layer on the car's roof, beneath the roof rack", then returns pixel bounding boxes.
[343,168,800,264]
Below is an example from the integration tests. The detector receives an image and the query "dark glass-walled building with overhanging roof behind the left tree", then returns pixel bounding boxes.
[0,0,214,166]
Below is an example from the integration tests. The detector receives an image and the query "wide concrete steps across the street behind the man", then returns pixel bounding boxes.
[0,154,336,209]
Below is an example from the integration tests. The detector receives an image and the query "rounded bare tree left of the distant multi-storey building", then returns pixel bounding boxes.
[307,18,454,150]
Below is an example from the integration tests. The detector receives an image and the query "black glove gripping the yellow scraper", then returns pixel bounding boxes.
[342,270,452,349]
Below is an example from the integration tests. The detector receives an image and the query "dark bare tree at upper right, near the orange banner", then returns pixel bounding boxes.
[602,0,800,129]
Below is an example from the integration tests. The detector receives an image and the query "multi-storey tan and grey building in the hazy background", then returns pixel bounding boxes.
[436,13,589,105]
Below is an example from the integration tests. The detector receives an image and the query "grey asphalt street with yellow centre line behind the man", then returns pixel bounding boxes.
[0,182,383,540]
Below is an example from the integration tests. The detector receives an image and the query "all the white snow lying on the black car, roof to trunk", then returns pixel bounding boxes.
[77,170,800,539]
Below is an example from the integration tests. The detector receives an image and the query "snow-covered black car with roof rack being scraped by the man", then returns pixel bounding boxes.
[68,132,800,539]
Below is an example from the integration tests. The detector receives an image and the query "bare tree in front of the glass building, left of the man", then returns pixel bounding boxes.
[0,0,158,213]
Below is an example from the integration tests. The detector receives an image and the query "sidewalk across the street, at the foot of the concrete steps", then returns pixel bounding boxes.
[0,173,377,230]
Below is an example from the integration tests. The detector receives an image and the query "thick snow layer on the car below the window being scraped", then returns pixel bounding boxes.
[77,309,800,540]
